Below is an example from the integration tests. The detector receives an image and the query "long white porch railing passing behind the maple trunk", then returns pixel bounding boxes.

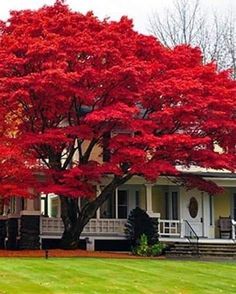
[40,217,127,235]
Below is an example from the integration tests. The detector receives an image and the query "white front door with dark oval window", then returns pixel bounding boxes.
[181,190,203,237]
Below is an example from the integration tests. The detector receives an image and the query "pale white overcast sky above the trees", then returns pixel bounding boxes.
[0,0,236,33]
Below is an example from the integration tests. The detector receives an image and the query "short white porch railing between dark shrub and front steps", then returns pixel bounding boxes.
[158,219,182,237]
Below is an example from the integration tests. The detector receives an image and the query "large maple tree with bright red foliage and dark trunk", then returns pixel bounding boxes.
[0,1,236,248]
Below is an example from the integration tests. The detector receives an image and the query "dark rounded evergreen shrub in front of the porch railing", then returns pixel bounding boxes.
[125,207,158,248]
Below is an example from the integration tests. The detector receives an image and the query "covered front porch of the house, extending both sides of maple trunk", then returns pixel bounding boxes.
[0,178,236,249]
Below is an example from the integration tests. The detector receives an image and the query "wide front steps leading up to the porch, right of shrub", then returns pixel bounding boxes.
[166,242,236,259]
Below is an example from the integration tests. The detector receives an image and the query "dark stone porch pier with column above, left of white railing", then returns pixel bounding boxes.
[19,195,41,249]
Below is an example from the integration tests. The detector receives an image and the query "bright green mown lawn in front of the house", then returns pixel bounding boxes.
[0,258,236,294]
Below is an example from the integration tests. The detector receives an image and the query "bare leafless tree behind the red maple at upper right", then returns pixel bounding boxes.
[149,0,236,79]
